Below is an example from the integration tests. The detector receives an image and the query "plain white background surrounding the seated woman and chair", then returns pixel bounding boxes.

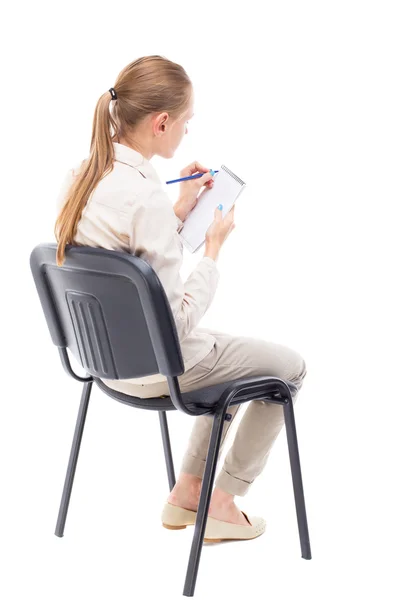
[0,0,400,600]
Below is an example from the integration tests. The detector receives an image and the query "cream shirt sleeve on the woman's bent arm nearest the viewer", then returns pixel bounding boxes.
[128,190,219,341]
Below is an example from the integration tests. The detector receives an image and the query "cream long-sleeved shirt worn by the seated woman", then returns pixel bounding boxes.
[57,142,219,389]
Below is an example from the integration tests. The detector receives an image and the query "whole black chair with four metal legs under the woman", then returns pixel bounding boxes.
[30,243,311,596]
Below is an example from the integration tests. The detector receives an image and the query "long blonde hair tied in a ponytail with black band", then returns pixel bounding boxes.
[54,55,192,266]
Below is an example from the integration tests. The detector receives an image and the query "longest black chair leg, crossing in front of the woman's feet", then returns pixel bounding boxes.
[183,409,226,596]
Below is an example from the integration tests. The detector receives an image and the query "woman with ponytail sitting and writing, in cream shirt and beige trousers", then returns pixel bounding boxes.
[55,56,306,540]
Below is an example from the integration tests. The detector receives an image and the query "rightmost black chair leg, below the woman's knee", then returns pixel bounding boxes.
[283,396,311,560]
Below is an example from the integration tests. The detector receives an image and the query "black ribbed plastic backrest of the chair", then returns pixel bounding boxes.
[30,243,184,379]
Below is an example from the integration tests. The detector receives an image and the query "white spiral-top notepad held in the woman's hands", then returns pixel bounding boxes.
[178,165,246,253]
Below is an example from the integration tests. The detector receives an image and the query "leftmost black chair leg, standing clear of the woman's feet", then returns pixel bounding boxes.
[55,381,93,537]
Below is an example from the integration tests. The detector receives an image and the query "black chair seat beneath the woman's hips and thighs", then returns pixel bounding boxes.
[93,376,297,414]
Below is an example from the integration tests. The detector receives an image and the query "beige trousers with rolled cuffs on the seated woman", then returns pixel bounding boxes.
[109,328,307,496]
